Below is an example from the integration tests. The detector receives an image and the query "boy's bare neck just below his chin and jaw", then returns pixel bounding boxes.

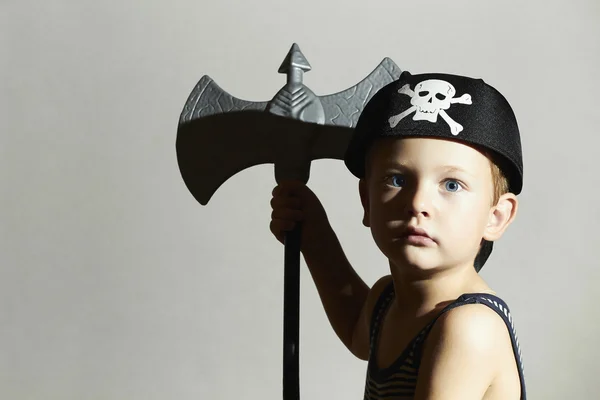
[390,261,493,315]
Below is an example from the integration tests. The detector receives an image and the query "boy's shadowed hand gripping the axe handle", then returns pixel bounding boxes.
[270,181,331,252]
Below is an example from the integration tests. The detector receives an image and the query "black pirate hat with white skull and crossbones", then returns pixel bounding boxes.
[344,71,523,271]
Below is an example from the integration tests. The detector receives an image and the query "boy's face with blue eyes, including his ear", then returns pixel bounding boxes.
[361,138,516,269]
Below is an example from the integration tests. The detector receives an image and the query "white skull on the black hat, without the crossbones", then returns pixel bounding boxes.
[410,79,456,122]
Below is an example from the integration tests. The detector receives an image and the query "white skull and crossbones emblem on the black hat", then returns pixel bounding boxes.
[389,79,472,136]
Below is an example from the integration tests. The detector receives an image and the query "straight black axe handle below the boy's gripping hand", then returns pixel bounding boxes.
[283,224,302,400]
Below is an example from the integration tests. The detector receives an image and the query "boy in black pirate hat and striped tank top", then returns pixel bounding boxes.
[270,72,526,400]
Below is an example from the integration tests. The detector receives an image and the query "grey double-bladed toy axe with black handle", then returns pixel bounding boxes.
[176,43,401,400]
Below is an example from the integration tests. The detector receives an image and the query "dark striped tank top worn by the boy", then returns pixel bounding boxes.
[364,283,527,400]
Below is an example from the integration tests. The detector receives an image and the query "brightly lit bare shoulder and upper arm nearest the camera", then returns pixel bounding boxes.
[415,304,512,400]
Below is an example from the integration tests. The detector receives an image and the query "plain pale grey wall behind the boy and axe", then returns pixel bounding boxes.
[0,0,600,400]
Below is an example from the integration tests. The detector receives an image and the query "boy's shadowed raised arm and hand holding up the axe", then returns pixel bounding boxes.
[271,182,386,360]
